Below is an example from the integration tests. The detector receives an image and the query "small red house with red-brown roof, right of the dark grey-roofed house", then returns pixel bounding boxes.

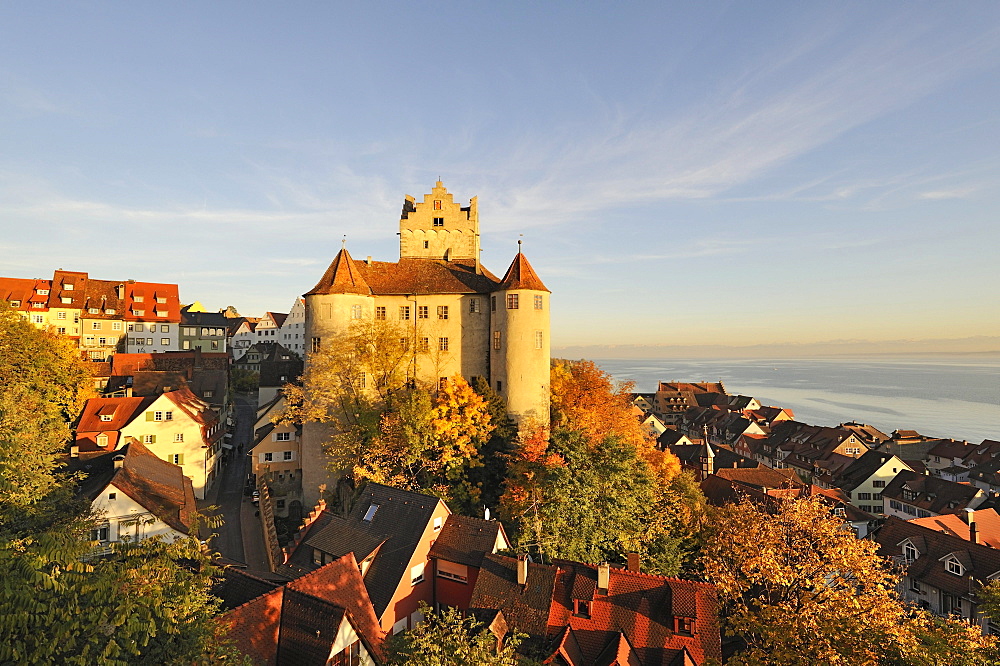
[428,513,511,609]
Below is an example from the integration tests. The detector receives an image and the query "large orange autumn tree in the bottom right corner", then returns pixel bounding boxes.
[702,497,995,665]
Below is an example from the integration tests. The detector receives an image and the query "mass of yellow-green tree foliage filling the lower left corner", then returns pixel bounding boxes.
[0,303,240,664]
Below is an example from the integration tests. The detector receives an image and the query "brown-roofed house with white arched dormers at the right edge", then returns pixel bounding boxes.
[873,516,1000,631]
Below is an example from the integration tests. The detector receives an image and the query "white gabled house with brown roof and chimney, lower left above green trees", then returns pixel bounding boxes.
[67,438,197,546]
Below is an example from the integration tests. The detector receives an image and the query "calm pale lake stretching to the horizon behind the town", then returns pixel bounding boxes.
[595,355,1000,443]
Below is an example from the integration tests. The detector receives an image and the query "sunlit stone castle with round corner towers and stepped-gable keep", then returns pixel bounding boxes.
[302,181,550,506]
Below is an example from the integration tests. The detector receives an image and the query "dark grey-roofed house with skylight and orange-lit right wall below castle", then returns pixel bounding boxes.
[277,483,451,634]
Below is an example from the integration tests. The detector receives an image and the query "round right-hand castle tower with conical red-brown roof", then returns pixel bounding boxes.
[490,241,551,426]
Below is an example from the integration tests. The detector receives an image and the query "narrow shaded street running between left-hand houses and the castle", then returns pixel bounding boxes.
[202,395,256,562]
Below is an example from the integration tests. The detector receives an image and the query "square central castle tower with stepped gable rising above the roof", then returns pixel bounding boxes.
[399,180,479,265]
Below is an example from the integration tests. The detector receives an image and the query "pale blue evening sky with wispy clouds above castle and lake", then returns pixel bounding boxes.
[0,1,1000,348]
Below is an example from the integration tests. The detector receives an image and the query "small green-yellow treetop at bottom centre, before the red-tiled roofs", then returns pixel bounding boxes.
[386,602,527,666]
